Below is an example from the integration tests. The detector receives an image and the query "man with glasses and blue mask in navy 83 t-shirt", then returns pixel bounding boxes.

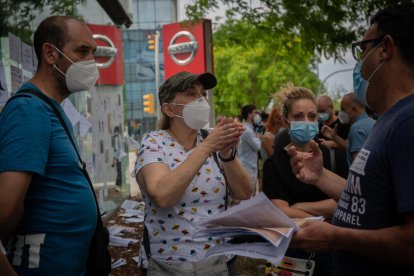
[289,2,414,276]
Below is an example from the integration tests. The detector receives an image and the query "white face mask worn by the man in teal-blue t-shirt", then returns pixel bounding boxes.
[52,45,99,93]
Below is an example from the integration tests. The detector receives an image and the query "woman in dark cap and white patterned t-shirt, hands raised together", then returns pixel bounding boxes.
[135,72,253,275]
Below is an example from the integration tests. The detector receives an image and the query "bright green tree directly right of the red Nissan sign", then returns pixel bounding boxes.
[214,21,319,115]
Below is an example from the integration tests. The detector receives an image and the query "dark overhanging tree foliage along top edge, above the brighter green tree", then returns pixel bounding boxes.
[186,0,411,60]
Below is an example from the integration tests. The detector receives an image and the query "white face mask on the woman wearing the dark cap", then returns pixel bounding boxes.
[172,97,210,130]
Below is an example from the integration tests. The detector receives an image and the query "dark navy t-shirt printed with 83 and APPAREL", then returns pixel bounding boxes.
[333,95,414,276]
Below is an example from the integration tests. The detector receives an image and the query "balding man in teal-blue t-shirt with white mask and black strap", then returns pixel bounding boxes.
[0,16,98,275]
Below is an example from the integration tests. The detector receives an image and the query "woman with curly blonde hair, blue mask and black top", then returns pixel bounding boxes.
[263,84,336,275]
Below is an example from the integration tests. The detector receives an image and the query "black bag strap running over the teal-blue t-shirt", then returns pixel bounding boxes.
[17,89,103,227]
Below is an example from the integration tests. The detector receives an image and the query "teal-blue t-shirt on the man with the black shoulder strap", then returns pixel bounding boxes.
[0,83,97,275]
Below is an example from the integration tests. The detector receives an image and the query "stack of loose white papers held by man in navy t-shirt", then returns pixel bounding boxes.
[195,193,322,265]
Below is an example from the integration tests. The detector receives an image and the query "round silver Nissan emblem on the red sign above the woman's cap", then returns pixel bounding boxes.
[168,31,198,65]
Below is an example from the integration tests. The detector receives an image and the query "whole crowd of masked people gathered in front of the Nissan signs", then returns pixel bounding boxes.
[0,3,414,275]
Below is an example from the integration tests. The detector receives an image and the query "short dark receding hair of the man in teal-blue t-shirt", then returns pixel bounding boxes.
[33,16,73,67]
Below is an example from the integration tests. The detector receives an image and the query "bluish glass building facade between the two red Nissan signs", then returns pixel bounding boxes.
[123,0,177,138]
